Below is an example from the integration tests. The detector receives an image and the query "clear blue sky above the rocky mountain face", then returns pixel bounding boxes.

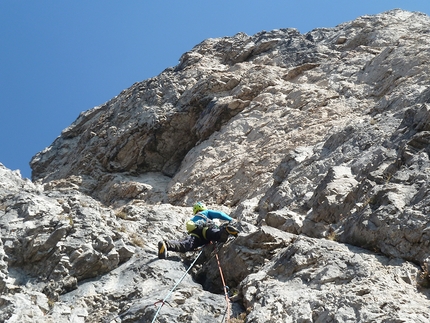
[0,0,430,178]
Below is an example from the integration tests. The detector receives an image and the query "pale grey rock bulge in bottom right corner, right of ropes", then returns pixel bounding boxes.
[241,230,430,322]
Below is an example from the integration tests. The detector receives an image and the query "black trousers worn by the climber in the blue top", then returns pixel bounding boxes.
[166,228,223,252]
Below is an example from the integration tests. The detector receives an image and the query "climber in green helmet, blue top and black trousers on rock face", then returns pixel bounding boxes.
[158,202,239,259]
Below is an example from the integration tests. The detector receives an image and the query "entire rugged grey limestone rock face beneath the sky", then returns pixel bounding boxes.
[0,10,430,323]
